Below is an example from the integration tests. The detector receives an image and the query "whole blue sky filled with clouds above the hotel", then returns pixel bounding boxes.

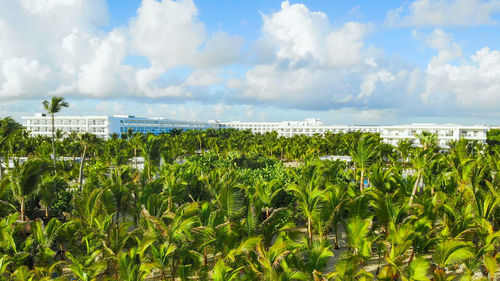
[0,0,500,125]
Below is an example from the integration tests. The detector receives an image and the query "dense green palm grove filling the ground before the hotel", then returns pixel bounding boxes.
[0,115,500,281]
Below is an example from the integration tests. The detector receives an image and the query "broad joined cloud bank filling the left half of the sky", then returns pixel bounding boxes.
[0,0,244,101]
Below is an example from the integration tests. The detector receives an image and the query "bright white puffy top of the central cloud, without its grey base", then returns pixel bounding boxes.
[262,1,369,66]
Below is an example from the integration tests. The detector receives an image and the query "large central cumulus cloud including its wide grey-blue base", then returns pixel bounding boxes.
[227,1,408,110]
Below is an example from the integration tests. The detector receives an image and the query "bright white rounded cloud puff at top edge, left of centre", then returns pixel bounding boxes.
[129,0,244,69]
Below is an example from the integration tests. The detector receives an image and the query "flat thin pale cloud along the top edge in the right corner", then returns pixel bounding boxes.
[385,0,500,27]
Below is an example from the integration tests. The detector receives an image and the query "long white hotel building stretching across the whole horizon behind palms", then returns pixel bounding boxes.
[22,113,489,147]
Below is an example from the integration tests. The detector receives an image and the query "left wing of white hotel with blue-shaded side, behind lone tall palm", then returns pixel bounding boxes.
[22,113,218,139]
